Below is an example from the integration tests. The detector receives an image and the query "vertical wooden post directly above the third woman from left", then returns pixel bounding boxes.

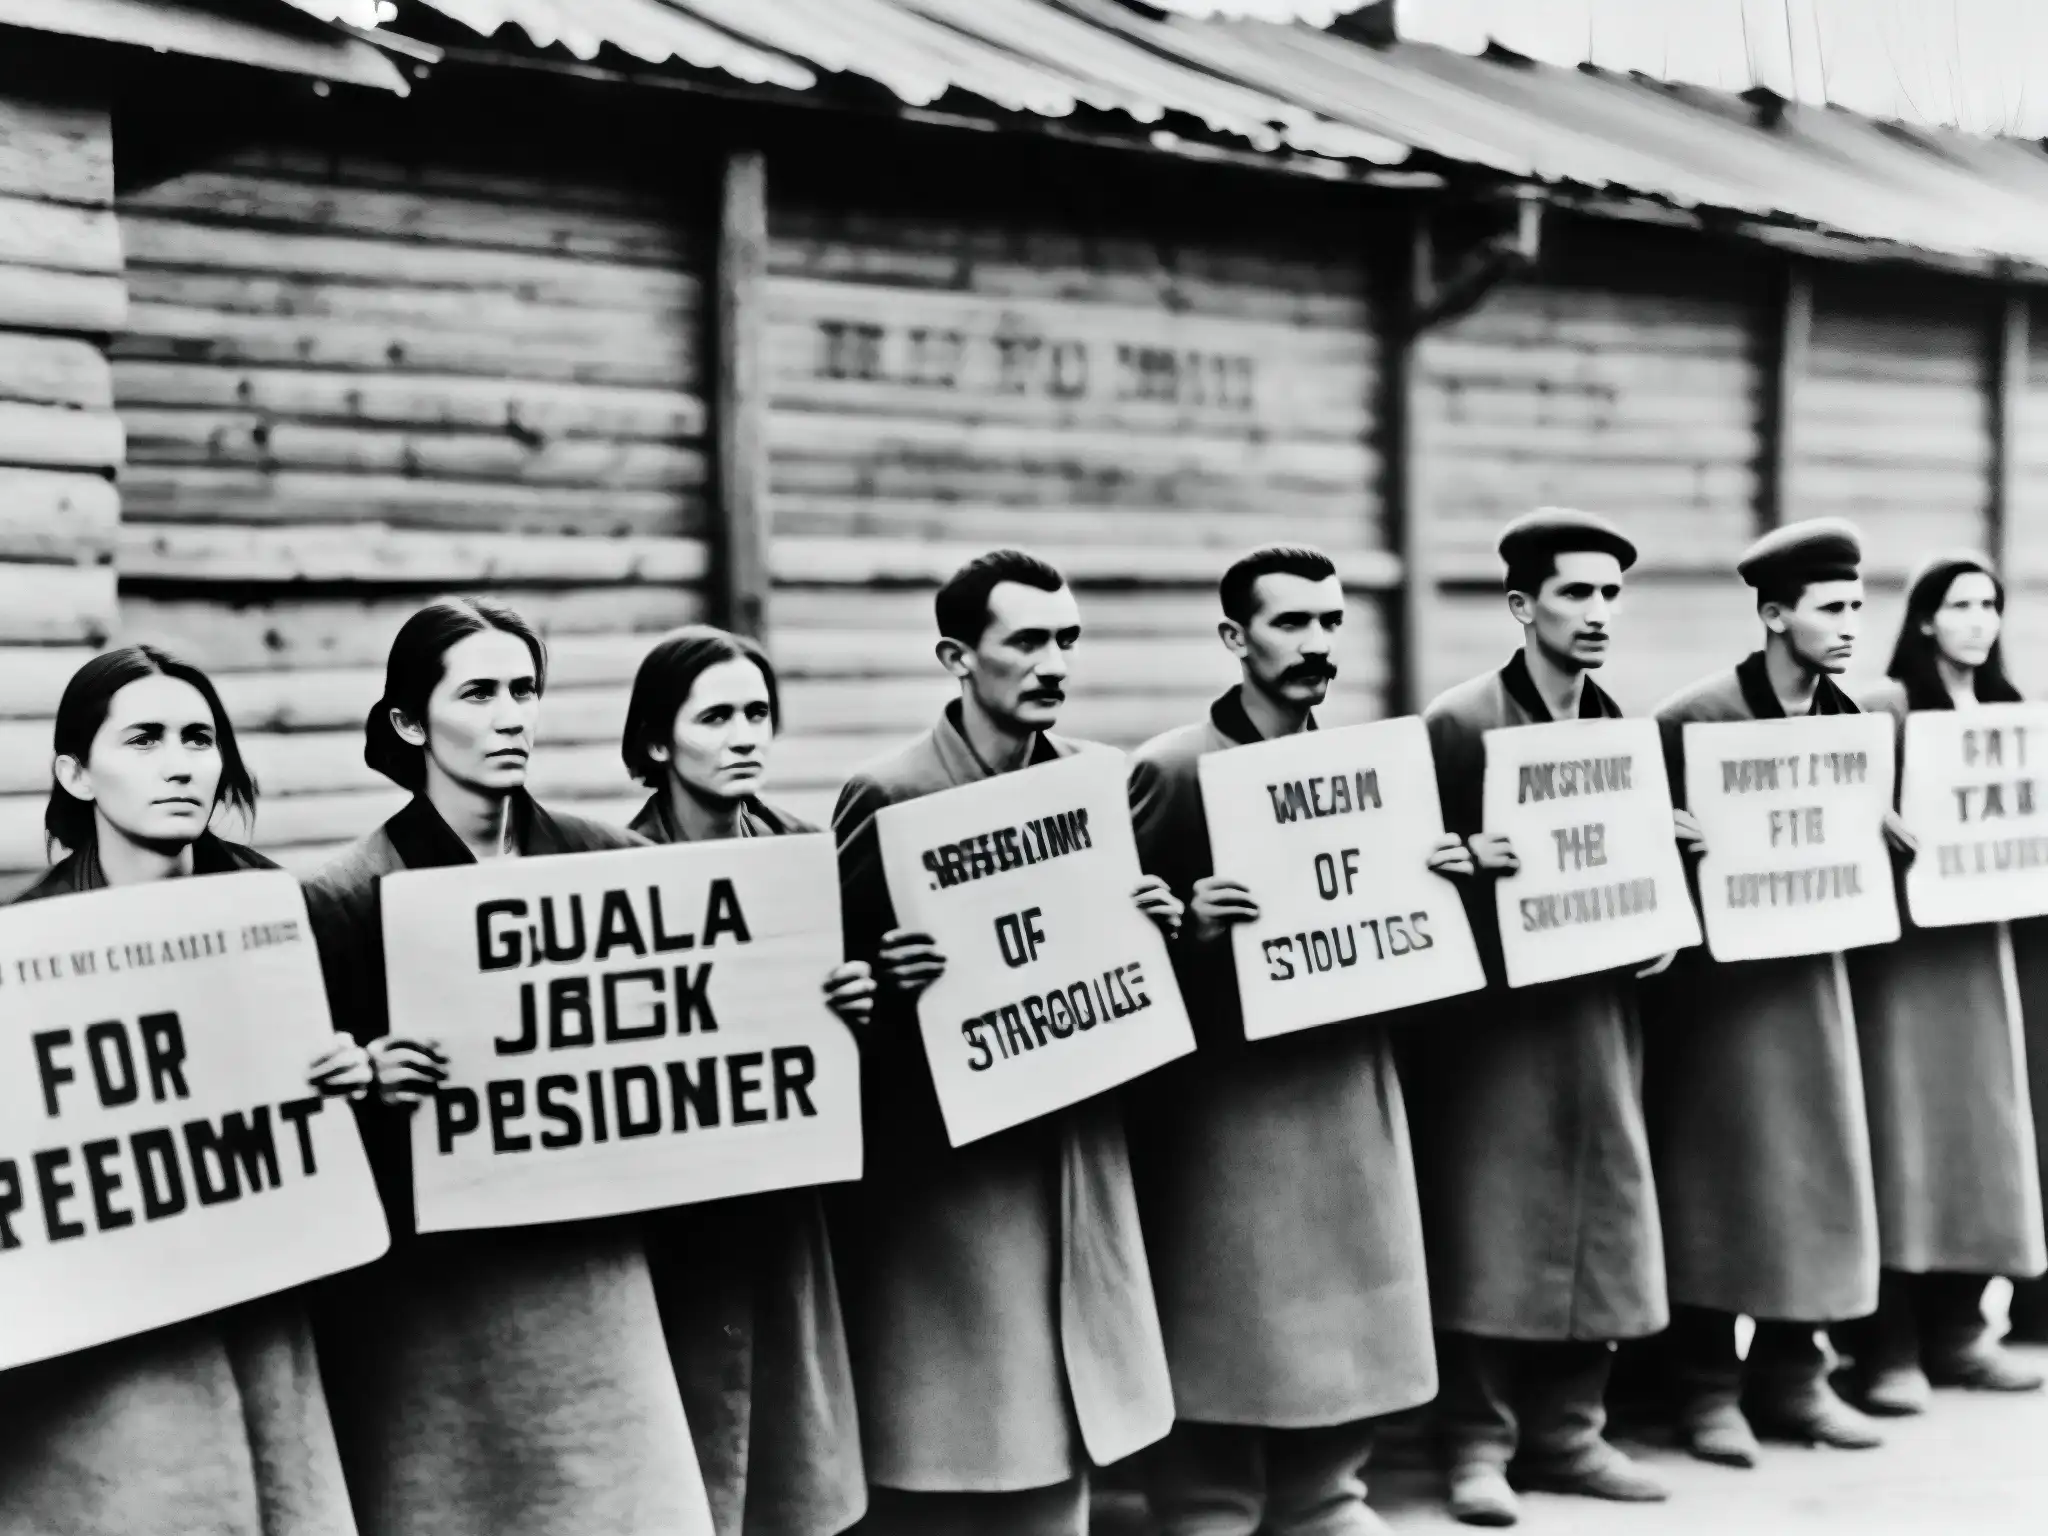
[709,150,770,639]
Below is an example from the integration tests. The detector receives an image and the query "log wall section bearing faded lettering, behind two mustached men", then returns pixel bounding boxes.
[768,201,1389,831]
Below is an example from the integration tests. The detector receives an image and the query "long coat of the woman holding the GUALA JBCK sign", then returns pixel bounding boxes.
[307,797,711,1536]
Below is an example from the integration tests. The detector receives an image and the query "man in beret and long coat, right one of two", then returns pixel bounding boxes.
[1645,518,1878,1466]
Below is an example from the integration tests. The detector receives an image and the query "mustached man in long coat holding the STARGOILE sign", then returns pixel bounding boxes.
[831,549,1182,1536]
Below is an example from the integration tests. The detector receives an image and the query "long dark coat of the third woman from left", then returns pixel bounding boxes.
[633,795,868,1536]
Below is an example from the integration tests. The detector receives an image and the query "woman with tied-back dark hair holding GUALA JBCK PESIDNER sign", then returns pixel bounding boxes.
[307,600,711,1536]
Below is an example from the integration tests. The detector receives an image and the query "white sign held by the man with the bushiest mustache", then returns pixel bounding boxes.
[1198,715,1487,1040]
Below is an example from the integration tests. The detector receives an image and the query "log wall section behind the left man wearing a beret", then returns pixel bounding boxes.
[1415,238,1765,709]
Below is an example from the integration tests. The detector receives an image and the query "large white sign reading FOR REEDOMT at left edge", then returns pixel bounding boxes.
[0,870,387,1370]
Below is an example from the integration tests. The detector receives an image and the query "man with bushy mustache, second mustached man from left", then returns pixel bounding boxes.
[1128,547,1470,1536]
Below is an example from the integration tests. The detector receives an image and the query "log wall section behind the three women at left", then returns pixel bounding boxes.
[115,150,705,862]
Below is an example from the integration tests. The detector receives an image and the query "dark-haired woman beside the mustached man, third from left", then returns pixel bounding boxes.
[621,627,874,1536]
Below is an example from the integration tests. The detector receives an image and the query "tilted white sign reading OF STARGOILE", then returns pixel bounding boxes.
[874,752,1194,1147]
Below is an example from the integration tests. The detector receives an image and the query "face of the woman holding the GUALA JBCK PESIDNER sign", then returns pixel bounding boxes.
[391,629,541,795]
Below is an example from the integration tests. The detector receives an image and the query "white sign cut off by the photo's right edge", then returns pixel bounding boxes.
[1898,705,2048,928]
